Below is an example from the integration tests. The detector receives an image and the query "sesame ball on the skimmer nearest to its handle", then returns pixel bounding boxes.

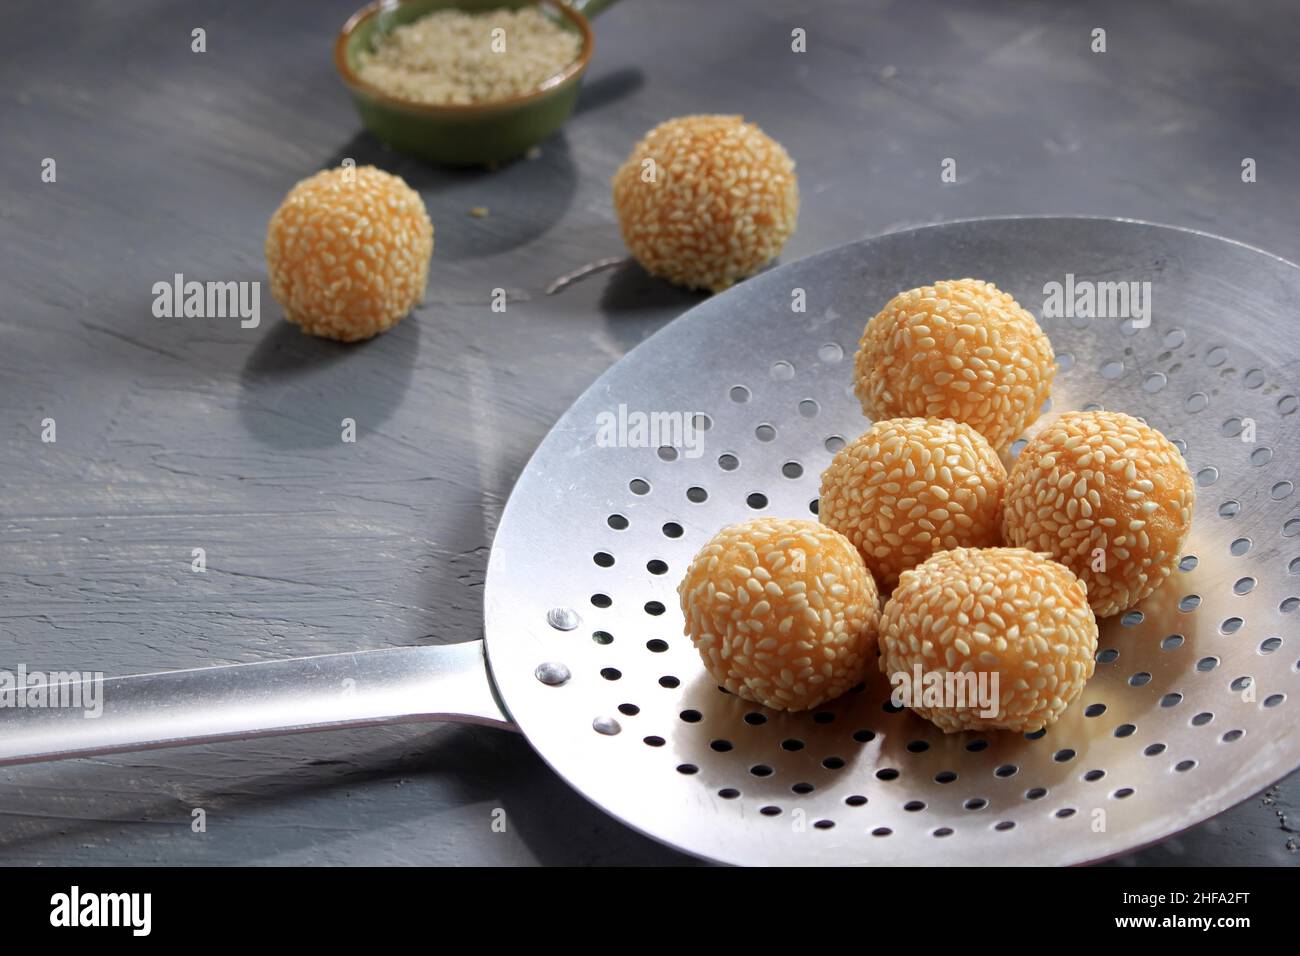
[677,518,880,710]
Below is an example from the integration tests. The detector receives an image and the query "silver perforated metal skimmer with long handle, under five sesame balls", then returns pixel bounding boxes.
[0,219,1300,865]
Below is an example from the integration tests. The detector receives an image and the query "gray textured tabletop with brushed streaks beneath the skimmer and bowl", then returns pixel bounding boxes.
[0,0,1300,864]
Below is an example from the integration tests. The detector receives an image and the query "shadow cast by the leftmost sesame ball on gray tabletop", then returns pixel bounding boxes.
[239,317,420,449]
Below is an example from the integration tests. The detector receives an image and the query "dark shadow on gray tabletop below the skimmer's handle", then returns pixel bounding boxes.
[0,724,693,866]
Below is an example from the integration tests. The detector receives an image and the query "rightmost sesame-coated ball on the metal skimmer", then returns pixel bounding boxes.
[1002,411,1196,618]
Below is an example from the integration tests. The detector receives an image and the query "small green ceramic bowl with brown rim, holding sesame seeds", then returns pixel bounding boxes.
[334,0,614,166]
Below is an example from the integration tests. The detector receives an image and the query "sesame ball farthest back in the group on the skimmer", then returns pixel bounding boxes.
[853,278,1056,451]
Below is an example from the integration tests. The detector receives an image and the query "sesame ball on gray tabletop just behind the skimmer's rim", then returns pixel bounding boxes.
[614,116,800,293]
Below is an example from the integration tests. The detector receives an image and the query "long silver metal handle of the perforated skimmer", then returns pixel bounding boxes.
[0,641,514,765]
